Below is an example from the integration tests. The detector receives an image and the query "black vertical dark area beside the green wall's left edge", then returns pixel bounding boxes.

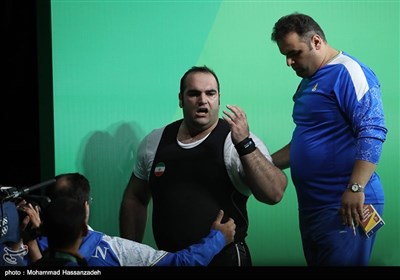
[0,0,54,187]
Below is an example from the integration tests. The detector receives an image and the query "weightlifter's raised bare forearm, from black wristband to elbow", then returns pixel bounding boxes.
[240,149,287,204]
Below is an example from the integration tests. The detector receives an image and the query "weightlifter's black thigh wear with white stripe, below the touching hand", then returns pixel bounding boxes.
[209,242,252,266]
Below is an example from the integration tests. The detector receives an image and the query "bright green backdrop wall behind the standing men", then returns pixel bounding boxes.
[51,0,400,266]
